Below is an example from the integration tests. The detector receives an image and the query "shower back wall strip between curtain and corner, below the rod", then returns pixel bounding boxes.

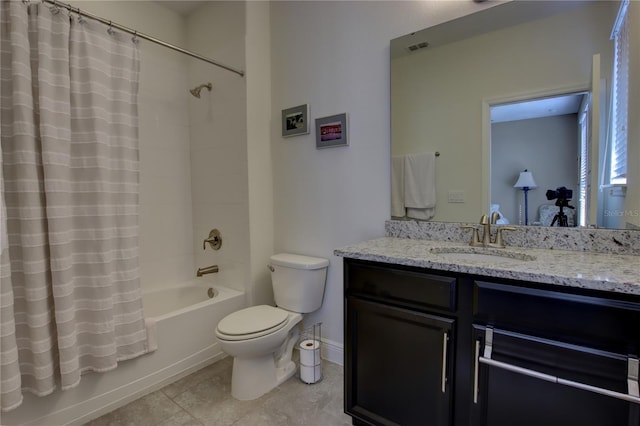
[139,38,194,290]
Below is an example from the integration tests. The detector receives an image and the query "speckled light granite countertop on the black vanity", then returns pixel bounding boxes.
[334,237,640,295]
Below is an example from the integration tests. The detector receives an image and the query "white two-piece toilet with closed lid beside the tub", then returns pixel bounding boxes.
[216,253,329,401]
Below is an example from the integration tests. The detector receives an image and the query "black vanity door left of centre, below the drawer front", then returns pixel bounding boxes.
[345,297,455,426]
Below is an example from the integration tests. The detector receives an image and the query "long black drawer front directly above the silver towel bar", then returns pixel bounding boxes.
[474,280,640,354]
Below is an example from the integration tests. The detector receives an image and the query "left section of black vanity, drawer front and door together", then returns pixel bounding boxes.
[345,261,464,426]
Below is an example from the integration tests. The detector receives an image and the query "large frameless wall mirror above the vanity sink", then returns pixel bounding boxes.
[391,1,640,228]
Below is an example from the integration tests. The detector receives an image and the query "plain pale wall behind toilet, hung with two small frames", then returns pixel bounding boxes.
[271,1,492,362]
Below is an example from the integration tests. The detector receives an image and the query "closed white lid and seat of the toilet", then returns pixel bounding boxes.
[216,305,289,340]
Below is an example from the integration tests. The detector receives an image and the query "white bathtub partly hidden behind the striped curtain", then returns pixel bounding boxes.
[2,280,245,426]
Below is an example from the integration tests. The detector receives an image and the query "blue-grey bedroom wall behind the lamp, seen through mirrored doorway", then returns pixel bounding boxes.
[491,114,579,225]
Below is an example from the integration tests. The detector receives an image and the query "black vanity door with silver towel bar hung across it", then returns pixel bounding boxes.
[472,326,640,426]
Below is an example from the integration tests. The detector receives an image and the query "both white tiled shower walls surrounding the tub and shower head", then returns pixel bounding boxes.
[73,1,249,290]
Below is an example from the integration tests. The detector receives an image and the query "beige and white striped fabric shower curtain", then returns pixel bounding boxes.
[0,0,147,411]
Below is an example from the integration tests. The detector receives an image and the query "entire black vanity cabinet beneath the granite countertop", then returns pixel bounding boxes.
[344,258,640,426]
